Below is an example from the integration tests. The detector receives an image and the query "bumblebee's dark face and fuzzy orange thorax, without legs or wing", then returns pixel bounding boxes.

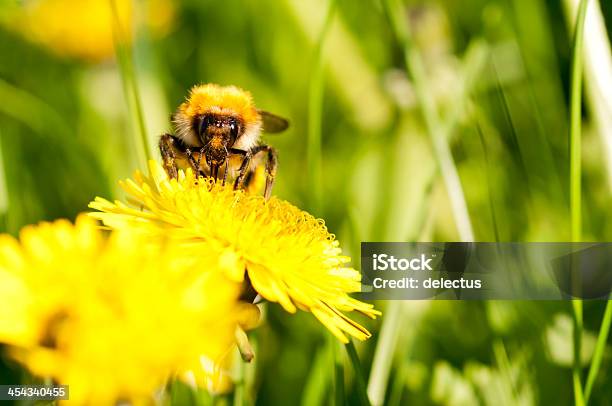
[172,84,261,151]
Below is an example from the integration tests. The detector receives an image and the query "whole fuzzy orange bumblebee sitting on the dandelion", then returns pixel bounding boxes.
[159,84,289,199]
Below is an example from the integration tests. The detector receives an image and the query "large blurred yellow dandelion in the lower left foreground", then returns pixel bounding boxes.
[0,216,244,404]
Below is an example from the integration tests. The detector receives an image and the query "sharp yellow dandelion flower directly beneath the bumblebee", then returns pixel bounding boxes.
[90,161,380,342]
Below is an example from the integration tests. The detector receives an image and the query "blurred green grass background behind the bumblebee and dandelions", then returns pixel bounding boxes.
[0,0,612,405]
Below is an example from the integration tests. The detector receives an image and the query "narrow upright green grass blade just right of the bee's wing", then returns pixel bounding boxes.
[306,0,336,213]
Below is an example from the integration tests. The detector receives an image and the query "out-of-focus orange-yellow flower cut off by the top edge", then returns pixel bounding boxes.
[5,0,174,61]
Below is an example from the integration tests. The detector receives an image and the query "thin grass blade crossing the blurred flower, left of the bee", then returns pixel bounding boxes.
[109,0,152,168]
